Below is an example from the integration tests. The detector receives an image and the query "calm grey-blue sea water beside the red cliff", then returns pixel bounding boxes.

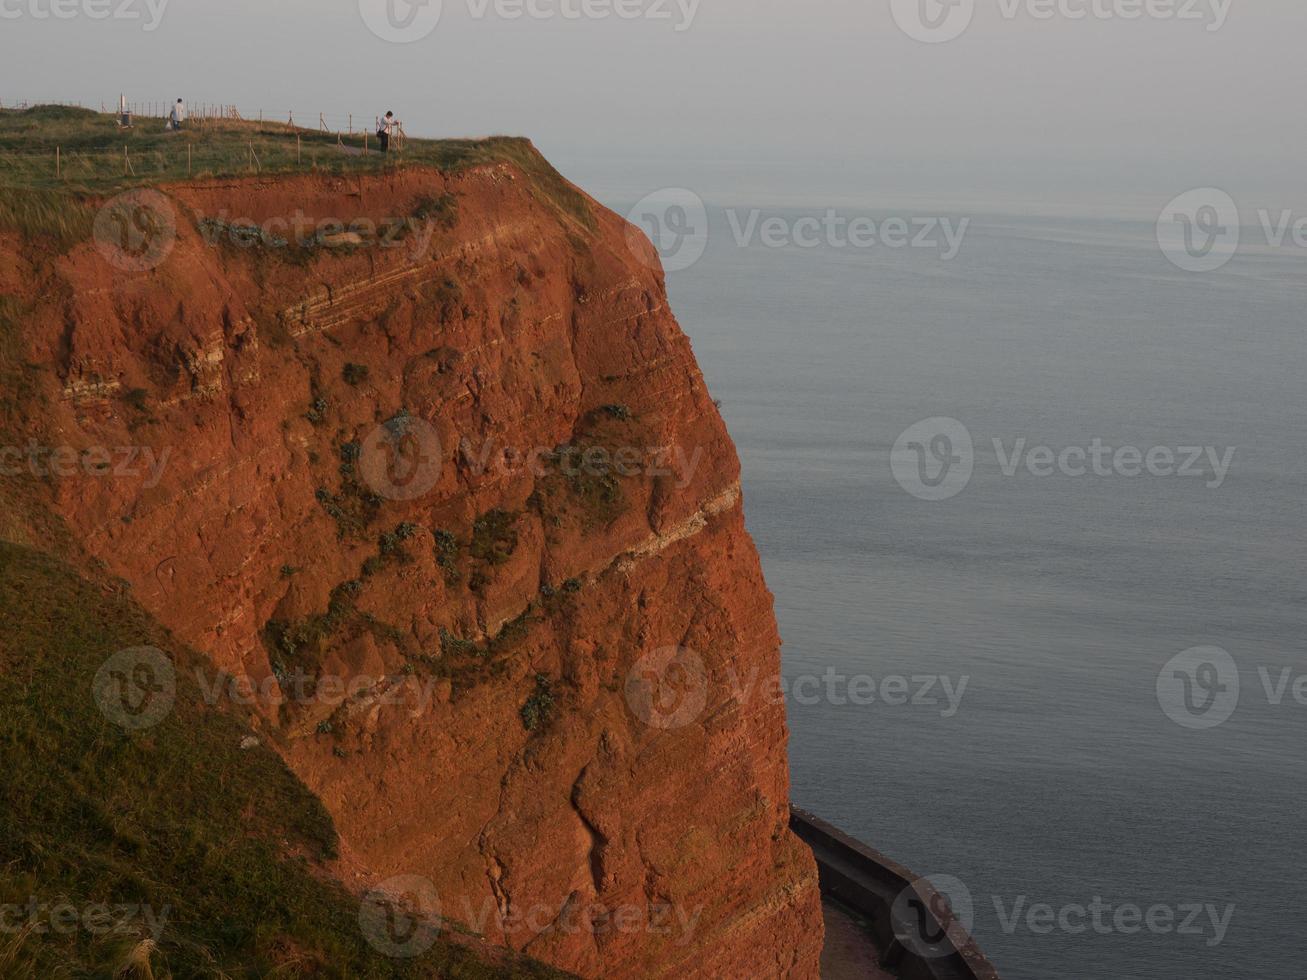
[577,172,1307,980]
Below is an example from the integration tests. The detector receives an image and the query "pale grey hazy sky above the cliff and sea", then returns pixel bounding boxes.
[0,0,1307,206]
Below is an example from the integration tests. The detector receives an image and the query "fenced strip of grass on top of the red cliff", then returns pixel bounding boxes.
[0,106,593,242]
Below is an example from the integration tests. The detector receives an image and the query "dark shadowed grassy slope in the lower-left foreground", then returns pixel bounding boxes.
[0,542,559,980]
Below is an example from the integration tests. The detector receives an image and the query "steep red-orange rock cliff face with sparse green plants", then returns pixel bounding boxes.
[0,147,822,977]
